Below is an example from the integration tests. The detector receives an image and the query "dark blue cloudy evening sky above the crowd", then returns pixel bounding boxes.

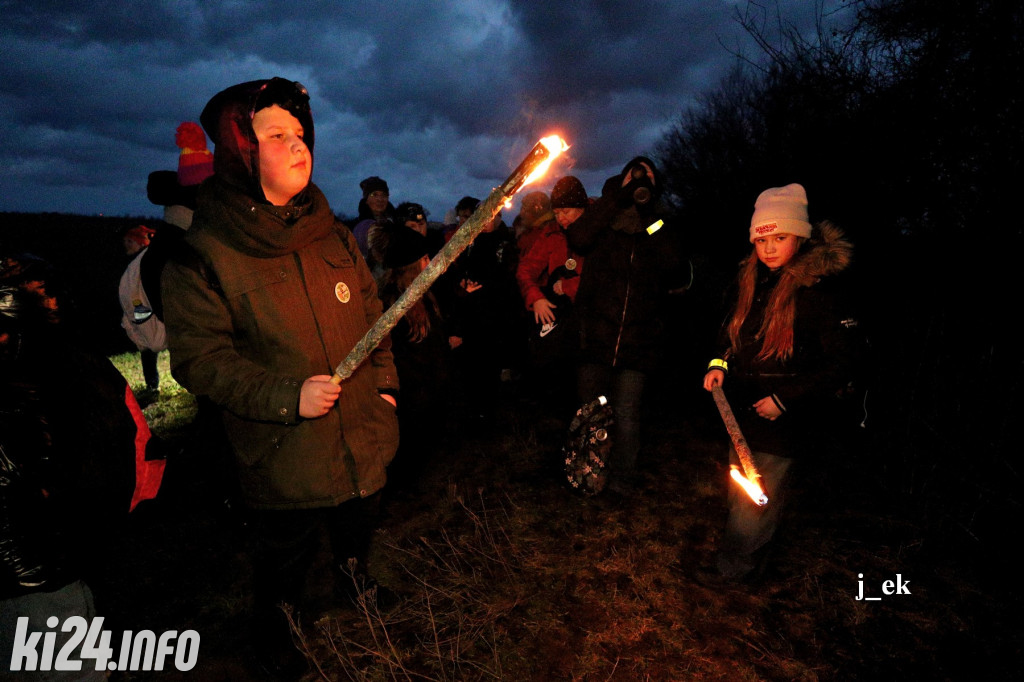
[0,0,850,220]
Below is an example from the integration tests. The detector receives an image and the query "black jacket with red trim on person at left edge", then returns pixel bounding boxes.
[0,339,151,599]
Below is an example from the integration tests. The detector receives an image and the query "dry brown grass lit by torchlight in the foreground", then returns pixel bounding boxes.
[278,405,939,680]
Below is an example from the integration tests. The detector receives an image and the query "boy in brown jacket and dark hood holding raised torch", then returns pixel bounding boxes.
[163,78,397,670]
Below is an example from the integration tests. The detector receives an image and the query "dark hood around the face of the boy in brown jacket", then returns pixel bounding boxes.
[200,78,314,204]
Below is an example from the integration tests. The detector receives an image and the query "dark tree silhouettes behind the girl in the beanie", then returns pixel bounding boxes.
[658,0,1024,573]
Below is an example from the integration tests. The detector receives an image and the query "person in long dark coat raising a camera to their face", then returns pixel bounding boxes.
[566,157,691,485]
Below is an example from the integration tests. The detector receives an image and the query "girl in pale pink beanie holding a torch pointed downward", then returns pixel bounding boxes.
[703,184,856,581]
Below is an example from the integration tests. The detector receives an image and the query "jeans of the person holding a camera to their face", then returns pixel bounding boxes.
[577,364,646,474]
